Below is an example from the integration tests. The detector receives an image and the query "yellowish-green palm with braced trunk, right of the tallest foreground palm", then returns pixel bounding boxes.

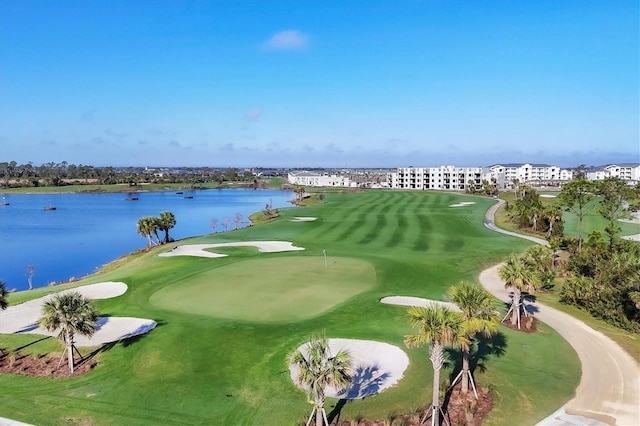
[449,282,500,399]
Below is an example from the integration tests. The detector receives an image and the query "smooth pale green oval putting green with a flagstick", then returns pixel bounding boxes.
[149,256,376,322]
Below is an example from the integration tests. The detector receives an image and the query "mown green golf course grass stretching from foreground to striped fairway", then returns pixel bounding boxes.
[0,191,580,425]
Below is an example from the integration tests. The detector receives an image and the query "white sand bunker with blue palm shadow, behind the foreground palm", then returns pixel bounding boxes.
[289,339,409,399]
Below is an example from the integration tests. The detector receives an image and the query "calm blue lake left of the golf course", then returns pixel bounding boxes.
[0,189,294,290]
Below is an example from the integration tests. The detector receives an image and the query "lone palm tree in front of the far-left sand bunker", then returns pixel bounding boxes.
[39,292,98,374]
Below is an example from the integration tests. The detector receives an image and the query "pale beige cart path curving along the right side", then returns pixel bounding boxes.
[479,200,640,426]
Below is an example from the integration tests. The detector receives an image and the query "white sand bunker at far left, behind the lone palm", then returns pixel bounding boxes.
[0,282,156,346]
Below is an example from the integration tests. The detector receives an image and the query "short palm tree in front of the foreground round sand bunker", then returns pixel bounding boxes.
[288,335,352,426]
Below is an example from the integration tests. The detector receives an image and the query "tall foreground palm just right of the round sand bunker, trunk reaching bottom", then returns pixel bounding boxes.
[404,306,468,426]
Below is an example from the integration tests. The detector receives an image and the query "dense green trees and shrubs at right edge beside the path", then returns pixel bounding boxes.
[559,177,640,332]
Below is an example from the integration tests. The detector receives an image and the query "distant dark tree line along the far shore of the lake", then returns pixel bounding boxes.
[0,161,258,188]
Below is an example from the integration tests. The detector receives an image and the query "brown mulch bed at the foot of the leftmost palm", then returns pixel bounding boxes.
[0,351,98,379]
